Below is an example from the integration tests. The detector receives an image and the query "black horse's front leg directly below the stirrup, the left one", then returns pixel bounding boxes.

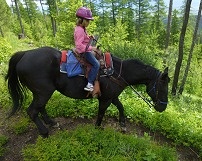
[95,99,112,127]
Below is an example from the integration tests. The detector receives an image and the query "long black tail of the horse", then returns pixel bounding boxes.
[5,52,25,117]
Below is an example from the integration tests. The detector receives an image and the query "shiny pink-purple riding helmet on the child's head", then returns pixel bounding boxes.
[76,7,94,20]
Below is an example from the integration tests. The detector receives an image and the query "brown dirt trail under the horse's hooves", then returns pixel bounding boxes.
[0,107,200,161]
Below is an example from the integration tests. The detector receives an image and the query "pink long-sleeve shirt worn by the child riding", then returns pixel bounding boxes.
[74,26,92,53]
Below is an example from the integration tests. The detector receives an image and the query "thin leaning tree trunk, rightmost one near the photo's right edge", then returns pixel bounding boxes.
[179,0,202,94]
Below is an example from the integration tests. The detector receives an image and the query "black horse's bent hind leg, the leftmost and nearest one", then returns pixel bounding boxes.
[27,94,51,137]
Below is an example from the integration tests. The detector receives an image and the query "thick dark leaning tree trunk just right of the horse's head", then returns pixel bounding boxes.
[172,0,192,95]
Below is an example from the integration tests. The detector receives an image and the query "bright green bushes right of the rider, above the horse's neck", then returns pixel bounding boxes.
[100,19,160,66]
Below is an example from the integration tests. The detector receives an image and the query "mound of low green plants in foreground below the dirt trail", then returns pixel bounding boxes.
[23,126,177,161]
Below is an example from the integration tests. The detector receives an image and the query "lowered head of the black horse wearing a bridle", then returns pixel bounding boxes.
[147,68,170,112]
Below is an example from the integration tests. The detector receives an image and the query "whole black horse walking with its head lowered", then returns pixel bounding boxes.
[6,47,169,137]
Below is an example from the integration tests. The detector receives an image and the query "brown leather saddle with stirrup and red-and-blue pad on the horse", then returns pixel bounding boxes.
[60,49,114,98]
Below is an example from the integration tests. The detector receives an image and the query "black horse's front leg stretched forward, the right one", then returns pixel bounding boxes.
[112,97,126,133]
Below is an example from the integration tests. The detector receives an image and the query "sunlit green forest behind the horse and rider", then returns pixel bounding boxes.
[0,0,202,96]
